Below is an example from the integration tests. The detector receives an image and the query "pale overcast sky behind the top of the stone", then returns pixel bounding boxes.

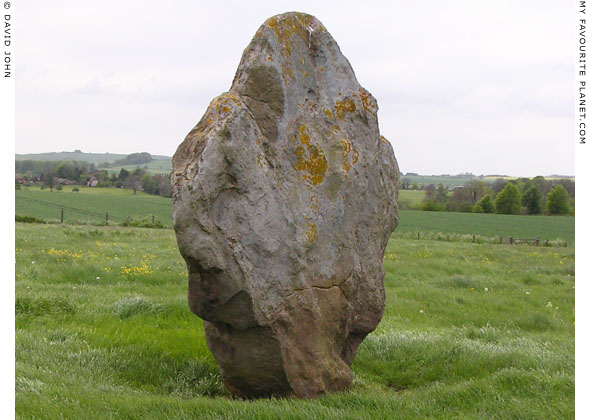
[15,0,575,176]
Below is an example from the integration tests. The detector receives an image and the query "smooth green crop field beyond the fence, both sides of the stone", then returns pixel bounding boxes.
[15,187,574,243]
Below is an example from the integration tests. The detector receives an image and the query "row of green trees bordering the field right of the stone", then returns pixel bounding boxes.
[408,176,575,215]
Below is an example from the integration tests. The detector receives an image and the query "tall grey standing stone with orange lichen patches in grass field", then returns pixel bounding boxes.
[172,12,399,397]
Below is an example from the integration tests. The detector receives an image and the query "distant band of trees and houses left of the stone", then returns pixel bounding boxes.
[15,160,172,197]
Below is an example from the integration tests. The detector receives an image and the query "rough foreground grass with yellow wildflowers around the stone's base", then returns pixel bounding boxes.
[15,223,574,420]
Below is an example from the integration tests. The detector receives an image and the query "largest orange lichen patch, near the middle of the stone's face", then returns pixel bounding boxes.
[293,125,328,185]
